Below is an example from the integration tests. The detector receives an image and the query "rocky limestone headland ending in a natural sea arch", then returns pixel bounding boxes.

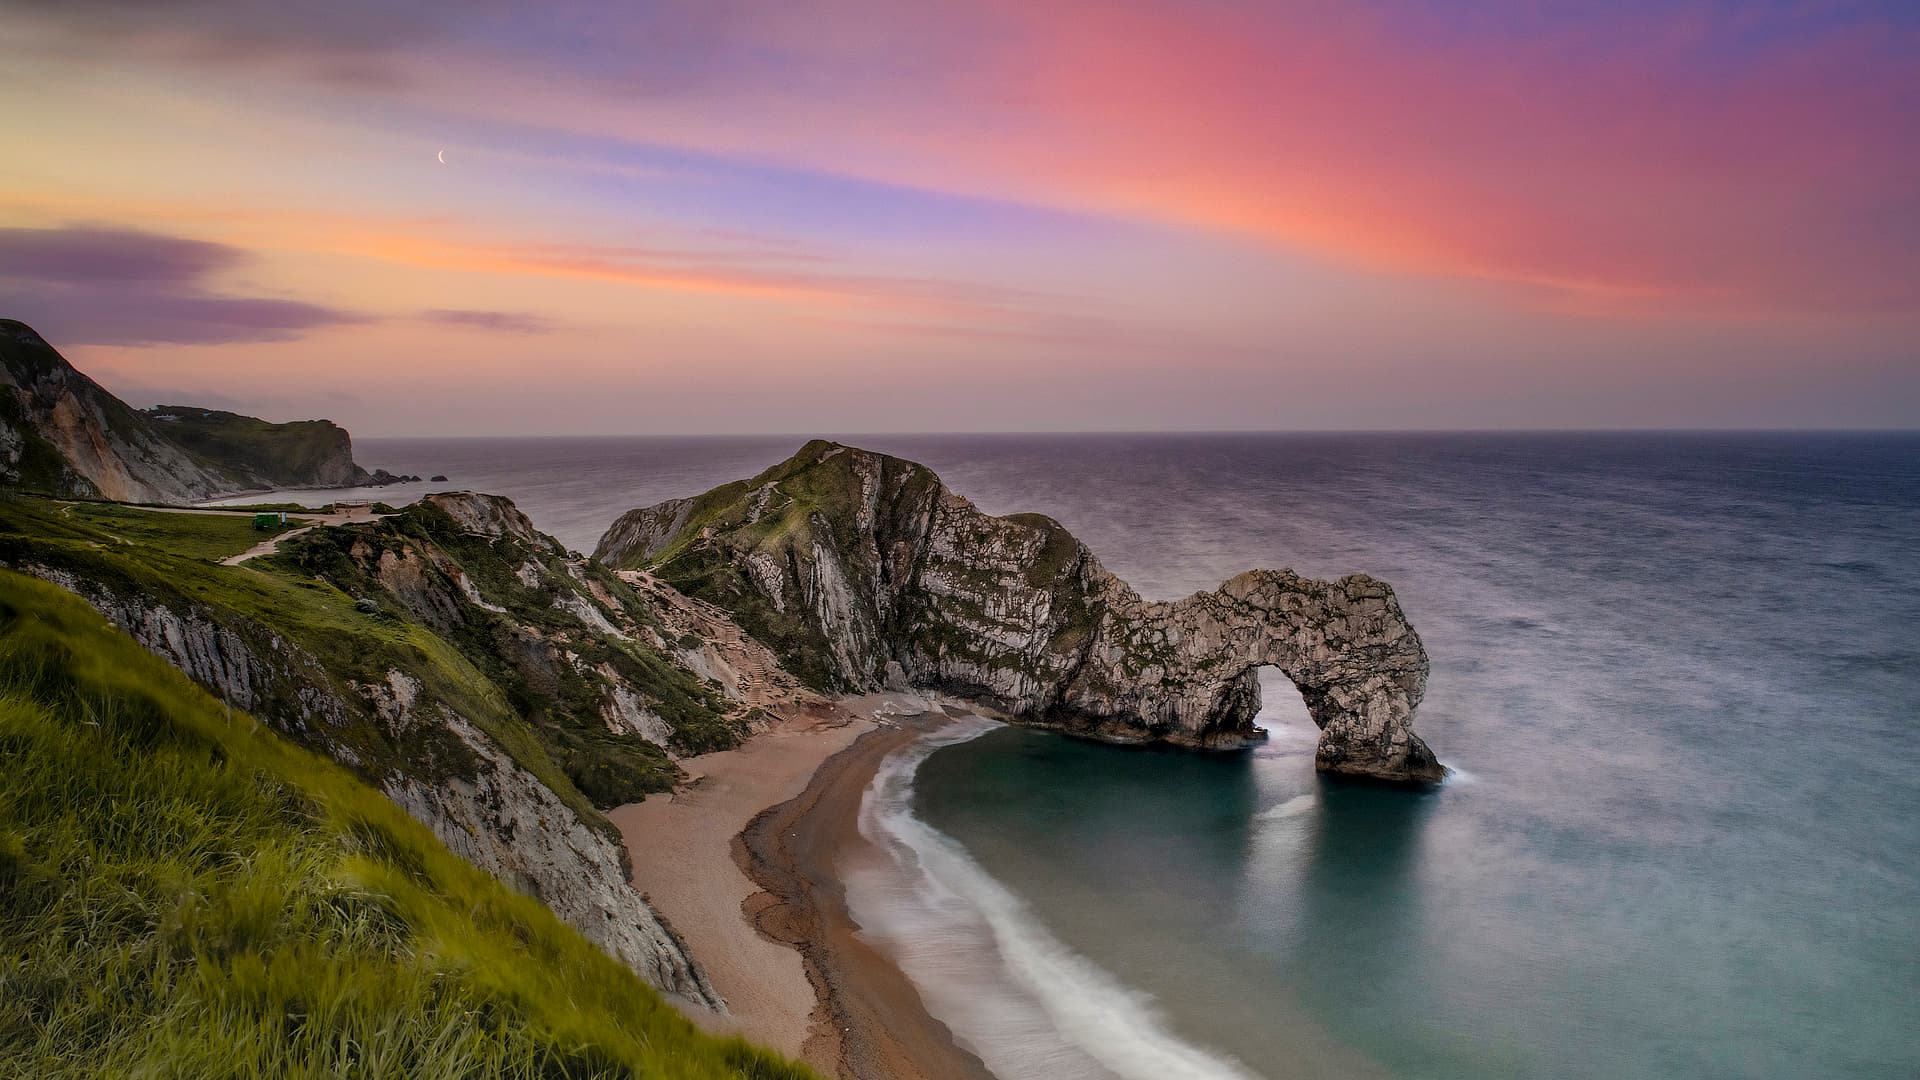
[595,440,1444,784]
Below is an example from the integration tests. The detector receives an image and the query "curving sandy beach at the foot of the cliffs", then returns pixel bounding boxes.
[609,696,991,1080]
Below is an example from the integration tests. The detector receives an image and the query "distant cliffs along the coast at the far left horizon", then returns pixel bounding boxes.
[0,319,387,502]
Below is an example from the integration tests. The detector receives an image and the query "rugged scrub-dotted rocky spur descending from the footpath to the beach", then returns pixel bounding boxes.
[299,492,762,772]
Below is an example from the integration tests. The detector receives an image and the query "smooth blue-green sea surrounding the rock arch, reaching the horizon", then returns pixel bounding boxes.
[217,432,1920,1080]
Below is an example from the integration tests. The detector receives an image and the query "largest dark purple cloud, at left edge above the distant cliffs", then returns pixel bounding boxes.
[0,225,367,346]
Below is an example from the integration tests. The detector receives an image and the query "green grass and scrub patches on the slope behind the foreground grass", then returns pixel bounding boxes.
[0,498,743,822]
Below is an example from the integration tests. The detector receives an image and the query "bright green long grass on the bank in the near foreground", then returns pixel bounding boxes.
[0,571,810,1080]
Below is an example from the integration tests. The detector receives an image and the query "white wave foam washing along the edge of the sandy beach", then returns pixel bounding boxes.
[849,721,1252,1080]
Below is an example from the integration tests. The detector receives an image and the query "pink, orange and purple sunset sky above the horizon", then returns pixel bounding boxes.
[0,0,1920,434]
